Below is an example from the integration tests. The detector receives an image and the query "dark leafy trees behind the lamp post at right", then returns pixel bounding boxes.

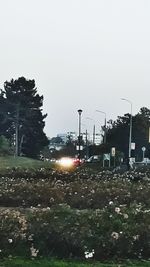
[107,107,150,161]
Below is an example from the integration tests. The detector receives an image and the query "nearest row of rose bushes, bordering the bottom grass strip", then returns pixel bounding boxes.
[0,205,150,259]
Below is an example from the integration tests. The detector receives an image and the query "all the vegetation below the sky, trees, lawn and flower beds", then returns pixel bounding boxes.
[0,70,150,267]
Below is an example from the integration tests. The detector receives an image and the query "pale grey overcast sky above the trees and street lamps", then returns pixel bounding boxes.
[0,0,150,137]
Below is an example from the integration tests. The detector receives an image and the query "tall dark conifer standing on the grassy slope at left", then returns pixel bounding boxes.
[0,77,48,157]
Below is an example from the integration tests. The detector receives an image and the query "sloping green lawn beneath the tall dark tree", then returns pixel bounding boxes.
[0,156,51,170]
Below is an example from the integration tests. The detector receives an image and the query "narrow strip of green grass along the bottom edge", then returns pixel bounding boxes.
[0,259,150,267]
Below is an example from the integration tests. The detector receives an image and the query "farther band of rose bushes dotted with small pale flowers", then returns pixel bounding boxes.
[0,169,150,209]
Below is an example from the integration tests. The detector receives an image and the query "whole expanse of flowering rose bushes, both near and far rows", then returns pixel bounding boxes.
[0,169,150,260]
